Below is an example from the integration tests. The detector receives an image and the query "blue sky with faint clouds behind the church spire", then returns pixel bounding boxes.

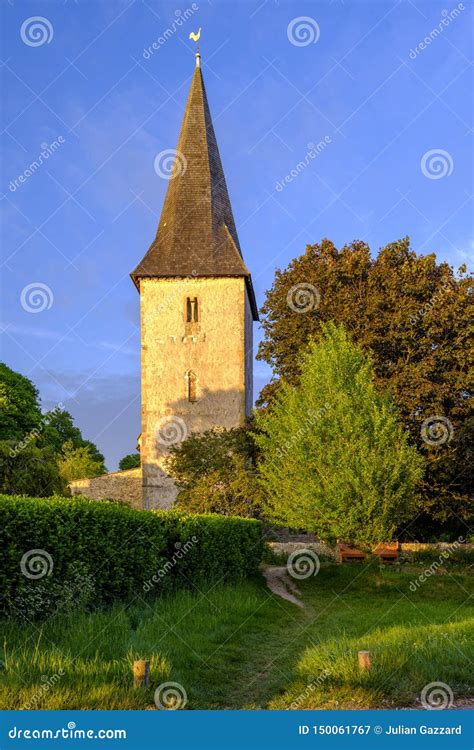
[1,0,474,469]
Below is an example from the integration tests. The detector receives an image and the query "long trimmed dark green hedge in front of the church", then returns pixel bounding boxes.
[0,495,263,617]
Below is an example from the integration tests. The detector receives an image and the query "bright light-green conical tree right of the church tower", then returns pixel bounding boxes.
[255,324,423,544]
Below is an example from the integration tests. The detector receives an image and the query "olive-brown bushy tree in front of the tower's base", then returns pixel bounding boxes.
[168,426,262,517]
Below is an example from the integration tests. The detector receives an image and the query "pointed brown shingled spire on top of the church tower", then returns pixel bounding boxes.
[131,53,258,320]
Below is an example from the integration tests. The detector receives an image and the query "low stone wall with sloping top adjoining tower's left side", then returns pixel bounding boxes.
[69,468,143,508]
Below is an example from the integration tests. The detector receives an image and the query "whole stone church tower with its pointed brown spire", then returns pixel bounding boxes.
[131,54,258,508]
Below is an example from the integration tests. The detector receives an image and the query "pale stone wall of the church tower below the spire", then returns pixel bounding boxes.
[140,277,252,508]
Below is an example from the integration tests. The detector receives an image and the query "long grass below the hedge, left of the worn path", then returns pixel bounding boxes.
[0,583,288,709]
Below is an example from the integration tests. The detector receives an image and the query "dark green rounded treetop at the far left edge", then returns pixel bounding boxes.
[0,362,41,440]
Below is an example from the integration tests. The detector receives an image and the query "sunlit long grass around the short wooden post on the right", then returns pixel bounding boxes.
[270,619,474,709]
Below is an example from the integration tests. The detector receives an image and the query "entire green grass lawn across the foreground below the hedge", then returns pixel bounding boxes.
[0,561,474,709]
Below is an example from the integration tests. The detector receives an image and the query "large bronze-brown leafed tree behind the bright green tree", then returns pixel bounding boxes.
[258,238,474,537]
